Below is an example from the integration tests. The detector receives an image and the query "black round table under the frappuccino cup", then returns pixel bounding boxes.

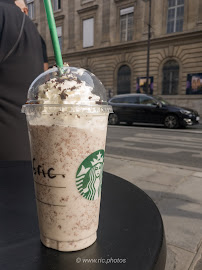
[0,161,166,270]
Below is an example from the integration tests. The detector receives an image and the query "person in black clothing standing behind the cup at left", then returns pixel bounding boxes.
[0,0,43,160]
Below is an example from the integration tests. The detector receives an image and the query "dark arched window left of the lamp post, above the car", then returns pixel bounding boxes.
[117,65,131,95]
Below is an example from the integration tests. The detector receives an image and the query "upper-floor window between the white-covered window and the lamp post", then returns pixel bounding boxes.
[120,7,134,41]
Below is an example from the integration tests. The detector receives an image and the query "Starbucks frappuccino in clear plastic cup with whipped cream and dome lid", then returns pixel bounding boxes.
[23,68,111,251]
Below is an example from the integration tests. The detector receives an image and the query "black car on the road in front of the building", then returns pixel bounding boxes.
[109,94,200,128]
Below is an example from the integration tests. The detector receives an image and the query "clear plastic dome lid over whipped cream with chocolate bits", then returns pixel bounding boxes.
[26,67,107,105]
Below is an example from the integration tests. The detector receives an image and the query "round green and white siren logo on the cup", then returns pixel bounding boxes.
[76,150,104,201]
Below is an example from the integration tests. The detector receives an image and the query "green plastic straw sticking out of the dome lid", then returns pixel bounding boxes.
[44,0,63,75]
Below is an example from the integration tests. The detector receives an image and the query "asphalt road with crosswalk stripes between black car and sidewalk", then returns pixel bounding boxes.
[106,125,202,168]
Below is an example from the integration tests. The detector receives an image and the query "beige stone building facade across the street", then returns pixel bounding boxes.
[28,0,202,115]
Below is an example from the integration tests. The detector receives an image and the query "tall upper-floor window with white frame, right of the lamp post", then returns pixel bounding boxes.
[167,0,184,33]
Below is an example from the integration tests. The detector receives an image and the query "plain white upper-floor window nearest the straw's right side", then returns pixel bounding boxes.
[83,18,94,48]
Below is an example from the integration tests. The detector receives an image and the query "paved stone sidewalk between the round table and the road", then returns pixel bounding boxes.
[104,155,202,270]
